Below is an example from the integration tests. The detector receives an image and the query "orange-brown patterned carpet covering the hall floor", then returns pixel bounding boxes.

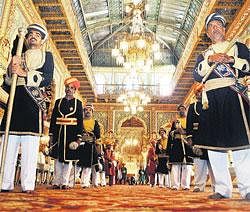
[0,185,250,211]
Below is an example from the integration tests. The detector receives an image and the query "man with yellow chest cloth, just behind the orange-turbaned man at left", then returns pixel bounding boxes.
[78,104,100,188]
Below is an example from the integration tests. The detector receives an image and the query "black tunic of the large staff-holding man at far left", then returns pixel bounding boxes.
[0,52,54,135]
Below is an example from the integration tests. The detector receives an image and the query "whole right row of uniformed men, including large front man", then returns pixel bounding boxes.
[148,13,250,200]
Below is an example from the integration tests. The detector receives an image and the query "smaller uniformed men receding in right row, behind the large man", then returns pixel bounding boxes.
[146,105,194,190]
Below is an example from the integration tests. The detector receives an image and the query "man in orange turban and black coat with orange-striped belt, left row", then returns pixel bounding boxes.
[49,77,83,189]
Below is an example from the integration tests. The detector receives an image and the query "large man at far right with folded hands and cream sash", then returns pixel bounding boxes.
[194,13,250,200]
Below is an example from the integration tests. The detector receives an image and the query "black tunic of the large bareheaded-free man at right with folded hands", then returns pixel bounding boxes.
[194,43,250,150]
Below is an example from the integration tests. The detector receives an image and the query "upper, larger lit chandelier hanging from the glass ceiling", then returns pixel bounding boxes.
[111,4,161,69]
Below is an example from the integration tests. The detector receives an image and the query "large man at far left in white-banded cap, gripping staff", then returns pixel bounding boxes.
[0,24,54,193]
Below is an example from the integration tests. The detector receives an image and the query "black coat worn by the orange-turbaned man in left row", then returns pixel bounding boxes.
[49,98,83,162]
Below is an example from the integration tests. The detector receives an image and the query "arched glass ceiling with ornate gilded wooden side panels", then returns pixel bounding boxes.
[33,0,250,104]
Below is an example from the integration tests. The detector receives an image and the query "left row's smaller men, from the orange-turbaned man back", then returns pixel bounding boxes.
[49,77,127,189]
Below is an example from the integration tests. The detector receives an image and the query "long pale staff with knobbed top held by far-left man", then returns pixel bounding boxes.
[0,27,27,190]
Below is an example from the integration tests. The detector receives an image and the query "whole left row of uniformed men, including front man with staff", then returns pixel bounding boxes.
[1,24,117,193]
